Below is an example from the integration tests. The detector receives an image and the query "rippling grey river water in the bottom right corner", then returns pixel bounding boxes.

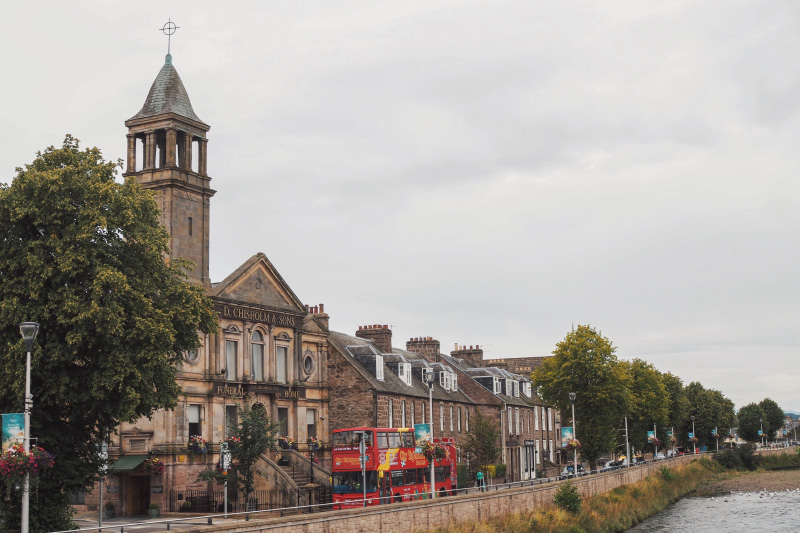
[628,488,800,533]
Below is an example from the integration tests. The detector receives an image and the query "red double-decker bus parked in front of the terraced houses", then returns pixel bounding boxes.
[331,428,458,509]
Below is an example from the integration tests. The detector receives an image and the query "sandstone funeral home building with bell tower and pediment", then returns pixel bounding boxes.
[92,54,328,515]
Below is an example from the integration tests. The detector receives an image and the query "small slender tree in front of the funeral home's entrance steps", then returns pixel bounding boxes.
[198,404,280,501]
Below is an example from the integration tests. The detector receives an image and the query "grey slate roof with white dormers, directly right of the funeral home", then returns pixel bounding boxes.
[328,331,475,403]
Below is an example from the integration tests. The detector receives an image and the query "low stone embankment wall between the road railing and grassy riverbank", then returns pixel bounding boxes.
[203,455,695,533]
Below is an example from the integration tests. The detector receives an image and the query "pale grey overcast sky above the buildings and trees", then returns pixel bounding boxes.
[0,0,800,411]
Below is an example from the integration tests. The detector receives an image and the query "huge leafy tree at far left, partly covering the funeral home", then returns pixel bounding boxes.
[0,136,217,531]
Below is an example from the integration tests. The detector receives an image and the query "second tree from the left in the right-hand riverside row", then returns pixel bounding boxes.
[620,359,669,450]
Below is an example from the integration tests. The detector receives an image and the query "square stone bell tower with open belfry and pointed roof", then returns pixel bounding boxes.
[123,54,216,288]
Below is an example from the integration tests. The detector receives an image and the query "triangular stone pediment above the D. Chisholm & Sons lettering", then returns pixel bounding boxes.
[208,253,307,314]
